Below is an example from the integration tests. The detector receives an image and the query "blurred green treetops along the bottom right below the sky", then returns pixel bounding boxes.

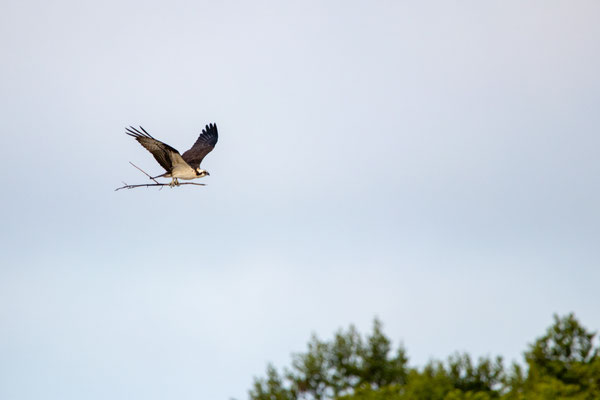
[250,314,600,400]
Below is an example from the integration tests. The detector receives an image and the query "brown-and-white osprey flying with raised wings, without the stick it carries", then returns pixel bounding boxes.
[125,124,219,187]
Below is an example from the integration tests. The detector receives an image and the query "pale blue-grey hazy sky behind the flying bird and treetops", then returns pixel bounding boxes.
[0,0,600,400]
